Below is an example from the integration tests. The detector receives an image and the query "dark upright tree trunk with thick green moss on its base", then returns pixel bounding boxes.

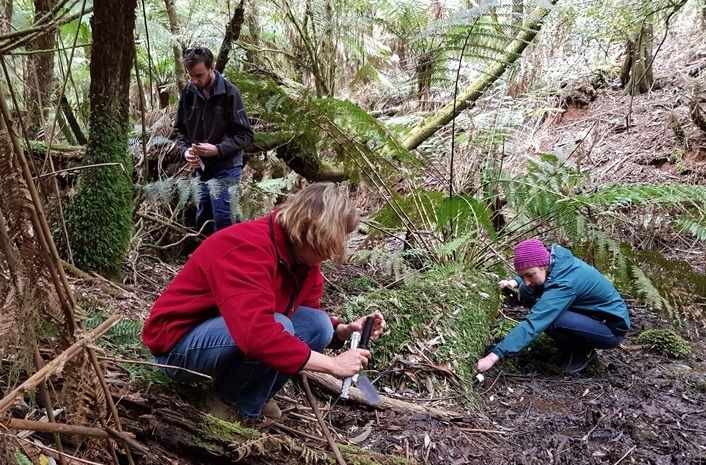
[66,0,137,277]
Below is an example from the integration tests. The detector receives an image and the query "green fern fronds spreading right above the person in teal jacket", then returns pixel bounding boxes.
[492,152,706,318]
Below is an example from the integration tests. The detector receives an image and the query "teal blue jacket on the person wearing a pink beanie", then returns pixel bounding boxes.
[491,245,630,359]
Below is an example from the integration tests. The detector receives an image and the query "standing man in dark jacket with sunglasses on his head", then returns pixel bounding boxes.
[171,47,253,234]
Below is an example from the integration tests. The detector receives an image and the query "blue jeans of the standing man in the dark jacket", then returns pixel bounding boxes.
[196,166,242,235]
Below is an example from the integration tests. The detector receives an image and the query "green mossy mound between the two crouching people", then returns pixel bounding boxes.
[352,267,499,387]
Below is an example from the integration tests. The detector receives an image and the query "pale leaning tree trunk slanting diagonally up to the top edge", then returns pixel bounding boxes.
[401,0,557,150]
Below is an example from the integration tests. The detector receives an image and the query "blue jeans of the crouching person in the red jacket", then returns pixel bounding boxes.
[155,307,333,419]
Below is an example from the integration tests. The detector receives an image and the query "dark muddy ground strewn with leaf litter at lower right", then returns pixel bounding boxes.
[249,290,706,465]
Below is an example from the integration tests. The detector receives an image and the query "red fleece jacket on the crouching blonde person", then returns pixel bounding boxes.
[142,213,337,374]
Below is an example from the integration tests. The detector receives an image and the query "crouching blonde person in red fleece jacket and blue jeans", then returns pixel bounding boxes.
[142,183,386,419]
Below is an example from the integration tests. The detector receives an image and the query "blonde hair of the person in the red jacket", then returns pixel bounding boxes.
[277,182,359,261]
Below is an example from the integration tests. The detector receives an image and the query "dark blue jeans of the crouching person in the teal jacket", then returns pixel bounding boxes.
[519,284,625,352]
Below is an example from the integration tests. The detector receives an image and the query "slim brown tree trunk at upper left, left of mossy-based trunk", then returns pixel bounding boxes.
[25,0,56,138]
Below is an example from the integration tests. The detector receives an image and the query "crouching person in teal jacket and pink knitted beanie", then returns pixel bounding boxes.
[477,239,630,373]
